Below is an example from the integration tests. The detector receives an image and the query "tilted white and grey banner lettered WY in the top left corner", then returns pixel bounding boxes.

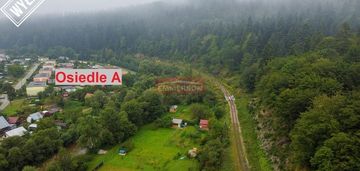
[1,0,45,27]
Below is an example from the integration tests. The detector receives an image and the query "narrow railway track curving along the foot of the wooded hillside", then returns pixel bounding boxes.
[218,83,250,171]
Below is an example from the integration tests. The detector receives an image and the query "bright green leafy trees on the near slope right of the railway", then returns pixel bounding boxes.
[253,30,360,170]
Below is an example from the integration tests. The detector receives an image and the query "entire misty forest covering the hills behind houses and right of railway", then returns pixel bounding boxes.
[0,0,360,170]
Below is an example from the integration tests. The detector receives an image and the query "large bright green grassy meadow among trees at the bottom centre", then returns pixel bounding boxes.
[89,125,199,171]
